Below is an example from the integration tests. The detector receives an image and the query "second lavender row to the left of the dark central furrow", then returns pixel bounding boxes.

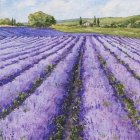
[0,38,78,112]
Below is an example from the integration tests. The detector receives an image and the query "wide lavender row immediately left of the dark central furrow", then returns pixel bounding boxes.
[0,36,82,140]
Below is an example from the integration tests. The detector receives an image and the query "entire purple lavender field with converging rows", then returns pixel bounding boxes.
[0,27,140,140]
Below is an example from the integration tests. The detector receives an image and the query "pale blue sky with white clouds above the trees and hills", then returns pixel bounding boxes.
[0,0,140,22]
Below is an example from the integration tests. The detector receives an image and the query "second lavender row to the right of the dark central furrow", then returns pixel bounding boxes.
[92,38,140,111]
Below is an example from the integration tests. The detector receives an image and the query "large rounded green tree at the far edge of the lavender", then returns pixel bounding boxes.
[28,11,56,27]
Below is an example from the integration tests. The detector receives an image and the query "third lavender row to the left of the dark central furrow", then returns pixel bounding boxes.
[0,37,72,86]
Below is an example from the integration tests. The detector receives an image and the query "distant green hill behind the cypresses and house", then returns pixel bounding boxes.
[57,15,140,27]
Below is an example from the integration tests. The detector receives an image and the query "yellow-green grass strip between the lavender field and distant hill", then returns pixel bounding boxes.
[52,25,140,38]
